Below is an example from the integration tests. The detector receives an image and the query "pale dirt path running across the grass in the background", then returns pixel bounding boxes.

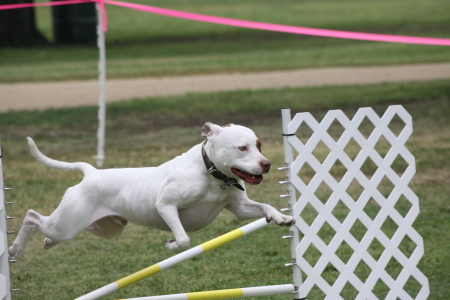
[0,63,450,112]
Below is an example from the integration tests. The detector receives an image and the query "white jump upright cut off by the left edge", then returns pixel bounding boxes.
[0,147,11,300]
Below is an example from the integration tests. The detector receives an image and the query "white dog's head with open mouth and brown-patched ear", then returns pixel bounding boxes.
[202,122,270,185]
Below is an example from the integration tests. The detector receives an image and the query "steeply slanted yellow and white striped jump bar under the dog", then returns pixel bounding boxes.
[75,218,270,300]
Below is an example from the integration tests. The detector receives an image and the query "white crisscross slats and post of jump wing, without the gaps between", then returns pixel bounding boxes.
[280,106,429,300]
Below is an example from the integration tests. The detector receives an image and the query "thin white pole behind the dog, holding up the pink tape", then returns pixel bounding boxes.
[94,2,106,167]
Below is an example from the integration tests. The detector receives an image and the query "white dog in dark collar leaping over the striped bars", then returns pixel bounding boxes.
[9,123,295,259]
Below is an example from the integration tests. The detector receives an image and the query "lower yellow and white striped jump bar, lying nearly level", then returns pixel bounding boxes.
[118,284,295,300]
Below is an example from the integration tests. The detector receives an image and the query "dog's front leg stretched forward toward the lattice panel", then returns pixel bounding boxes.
[225,197,295,226]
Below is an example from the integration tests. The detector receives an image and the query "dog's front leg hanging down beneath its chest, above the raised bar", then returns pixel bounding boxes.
[157,203,190,253]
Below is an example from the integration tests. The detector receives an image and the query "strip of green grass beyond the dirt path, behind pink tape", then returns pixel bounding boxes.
[0,0,450,82]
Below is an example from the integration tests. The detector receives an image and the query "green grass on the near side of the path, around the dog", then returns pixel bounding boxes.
[0,81,450,300]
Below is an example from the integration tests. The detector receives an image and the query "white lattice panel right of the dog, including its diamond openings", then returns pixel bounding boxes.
[284,106,429,300]
